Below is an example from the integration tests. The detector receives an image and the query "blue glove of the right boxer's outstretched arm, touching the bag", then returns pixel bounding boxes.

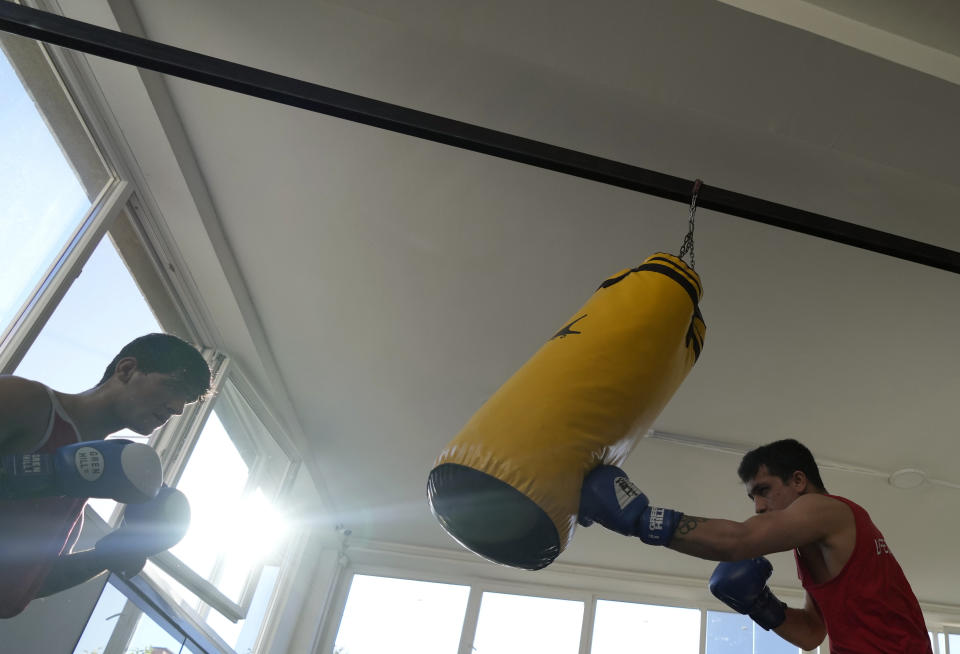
[577,465,683,545]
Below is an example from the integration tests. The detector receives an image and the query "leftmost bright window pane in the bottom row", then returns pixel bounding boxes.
[333,575,470,654]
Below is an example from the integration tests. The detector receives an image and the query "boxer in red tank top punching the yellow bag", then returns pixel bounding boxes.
[578,439,931,654]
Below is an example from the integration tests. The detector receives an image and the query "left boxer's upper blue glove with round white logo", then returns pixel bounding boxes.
[0,438,162,504]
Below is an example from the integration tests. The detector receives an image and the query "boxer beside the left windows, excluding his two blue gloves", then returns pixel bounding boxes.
[0,334,210,618]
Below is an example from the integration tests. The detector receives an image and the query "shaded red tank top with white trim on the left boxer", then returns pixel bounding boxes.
[0,388,86,618]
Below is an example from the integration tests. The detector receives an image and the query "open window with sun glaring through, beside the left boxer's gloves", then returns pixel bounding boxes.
[143,362,299,647]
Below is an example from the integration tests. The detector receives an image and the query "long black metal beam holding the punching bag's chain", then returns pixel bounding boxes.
[0,0,960,273]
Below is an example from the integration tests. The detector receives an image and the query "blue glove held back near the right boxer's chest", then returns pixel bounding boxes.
[710,556,787,631]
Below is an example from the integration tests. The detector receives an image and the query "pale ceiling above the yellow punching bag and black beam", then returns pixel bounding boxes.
[56,0,960,605]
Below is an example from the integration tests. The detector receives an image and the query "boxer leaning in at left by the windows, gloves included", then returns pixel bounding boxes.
[0,334,211,618]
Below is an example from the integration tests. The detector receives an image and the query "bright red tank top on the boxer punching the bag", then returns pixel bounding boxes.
[793,495,932,654]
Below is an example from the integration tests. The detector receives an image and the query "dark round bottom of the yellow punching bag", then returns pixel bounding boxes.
[427,463,560,570]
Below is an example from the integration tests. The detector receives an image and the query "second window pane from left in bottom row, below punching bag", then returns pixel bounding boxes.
[473,593,583,654]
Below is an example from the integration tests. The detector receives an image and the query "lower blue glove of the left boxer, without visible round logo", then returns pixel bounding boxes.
[93,486,190,577]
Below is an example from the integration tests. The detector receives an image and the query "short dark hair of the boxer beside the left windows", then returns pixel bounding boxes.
[97,334,210,399]
